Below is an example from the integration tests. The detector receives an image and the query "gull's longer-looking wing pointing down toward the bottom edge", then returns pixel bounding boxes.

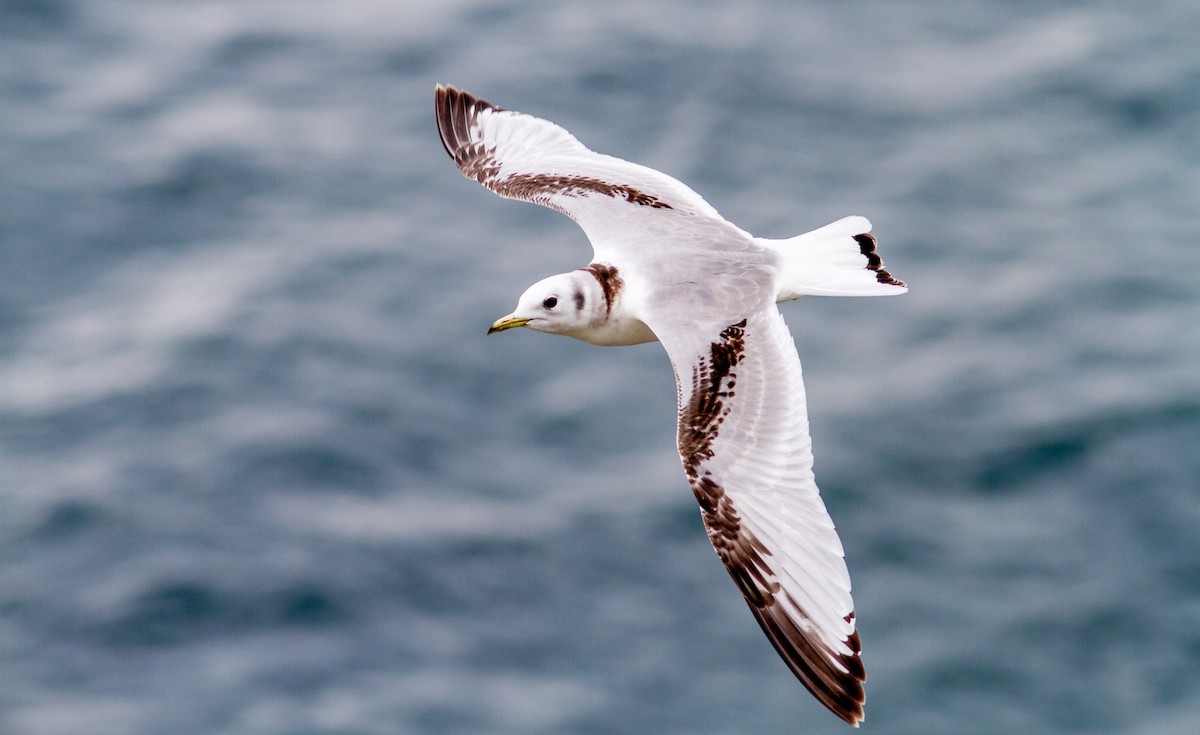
[648,305,865,724]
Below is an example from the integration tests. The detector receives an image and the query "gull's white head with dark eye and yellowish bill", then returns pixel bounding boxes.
[487,270,608,341]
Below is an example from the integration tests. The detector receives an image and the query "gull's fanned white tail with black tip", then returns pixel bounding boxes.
[755,216,908,301]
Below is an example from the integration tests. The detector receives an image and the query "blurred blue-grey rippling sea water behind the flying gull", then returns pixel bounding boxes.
[0,0,1200,735]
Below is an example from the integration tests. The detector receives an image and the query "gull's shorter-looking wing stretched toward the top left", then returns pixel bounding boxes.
[436,84,761,257]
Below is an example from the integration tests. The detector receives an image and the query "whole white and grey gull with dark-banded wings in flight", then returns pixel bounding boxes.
[436,84,907,727]
